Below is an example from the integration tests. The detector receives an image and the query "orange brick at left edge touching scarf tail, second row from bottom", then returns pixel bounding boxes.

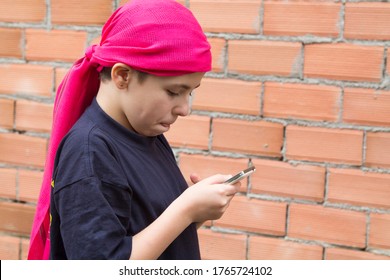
[0,201,35,235]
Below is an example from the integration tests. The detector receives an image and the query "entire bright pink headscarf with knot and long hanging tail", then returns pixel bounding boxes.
[28,0,211,259]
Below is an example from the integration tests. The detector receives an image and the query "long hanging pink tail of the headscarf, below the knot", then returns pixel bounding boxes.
[28,55,99,259]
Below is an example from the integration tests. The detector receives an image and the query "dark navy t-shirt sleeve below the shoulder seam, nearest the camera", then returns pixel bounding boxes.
[53,177,132,259]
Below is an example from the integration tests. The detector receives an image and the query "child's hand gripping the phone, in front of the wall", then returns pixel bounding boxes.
[180,174,241,222]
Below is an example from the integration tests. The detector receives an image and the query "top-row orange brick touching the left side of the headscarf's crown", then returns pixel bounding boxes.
[51,0,112,25]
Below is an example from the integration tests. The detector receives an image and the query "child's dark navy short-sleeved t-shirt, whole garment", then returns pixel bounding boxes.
[50,100,200,259]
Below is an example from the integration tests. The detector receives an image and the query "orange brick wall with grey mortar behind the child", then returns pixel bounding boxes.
[0,0,390,259]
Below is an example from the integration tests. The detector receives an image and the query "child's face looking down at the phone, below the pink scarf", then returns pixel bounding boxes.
[119,73,204,136]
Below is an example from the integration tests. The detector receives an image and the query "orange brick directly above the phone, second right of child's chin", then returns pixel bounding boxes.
[212,119,283,157]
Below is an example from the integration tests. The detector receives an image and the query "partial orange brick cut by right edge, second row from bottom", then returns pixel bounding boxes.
[368,213,390,250]
